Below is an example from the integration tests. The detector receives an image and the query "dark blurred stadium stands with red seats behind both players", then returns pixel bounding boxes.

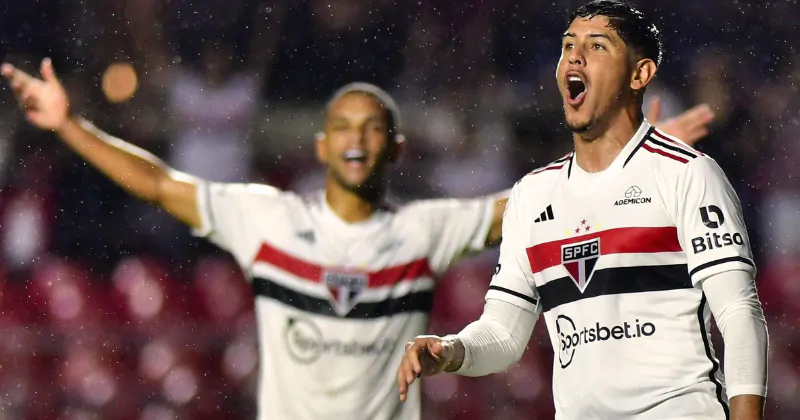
[0,0,800,420]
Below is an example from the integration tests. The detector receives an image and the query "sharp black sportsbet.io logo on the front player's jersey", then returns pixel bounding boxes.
[556,315,656,369]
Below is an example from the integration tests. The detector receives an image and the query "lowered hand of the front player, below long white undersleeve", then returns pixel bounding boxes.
[397,335,463,402]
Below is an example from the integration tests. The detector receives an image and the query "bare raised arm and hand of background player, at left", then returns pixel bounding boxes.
[2,59,201,227]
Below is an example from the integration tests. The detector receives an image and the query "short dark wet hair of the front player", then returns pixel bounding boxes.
[567,0,664,66]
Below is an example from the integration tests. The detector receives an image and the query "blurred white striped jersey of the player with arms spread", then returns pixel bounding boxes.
[195,183,494,420]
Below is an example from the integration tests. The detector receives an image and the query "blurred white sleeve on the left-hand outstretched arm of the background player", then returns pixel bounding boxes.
[192,181,287,264]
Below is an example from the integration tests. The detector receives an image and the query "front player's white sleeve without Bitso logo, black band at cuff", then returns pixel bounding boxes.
[486,188,541,316]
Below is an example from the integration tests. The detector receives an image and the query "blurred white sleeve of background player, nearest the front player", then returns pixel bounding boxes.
[424,198,495,274]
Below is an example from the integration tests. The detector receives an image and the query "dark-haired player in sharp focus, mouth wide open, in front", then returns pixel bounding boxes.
[397,0,768,419]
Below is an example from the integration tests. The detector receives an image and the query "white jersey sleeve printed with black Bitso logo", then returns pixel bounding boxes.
[675,156,756,285]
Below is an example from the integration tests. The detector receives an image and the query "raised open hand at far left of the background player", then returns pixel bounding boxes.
[0,58,69,130]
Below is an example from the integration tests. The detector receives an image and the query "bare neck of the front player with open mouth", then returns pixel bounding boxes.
[572,107,644,173]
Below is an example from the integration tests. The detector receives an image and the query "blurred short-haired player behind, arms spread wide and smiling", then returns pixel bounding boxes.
[2,54,712,420]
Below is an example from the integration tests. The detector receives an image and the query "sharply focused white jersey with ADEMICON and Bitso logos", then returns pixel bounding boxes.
[487,122,755,419]
